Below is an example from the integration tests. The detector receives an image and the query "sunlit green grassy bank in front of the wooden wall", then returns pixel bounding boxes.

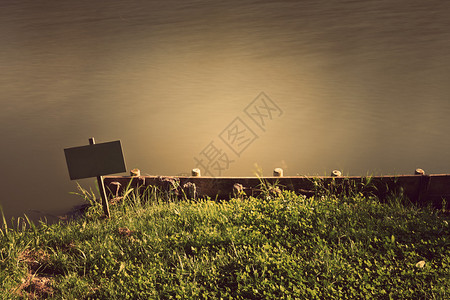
[0,184,450,299]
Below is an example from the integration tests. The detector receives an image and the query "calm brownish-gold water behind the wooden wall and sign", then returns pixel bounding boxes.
[0,0,450,218]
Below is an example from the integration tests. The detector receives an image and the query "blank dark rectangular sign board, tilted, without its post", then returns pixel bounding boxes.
[64,141,126,180]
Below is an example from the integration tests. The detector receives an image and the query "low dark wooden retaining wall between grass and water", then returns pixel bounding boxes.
[104,174,450,209]
